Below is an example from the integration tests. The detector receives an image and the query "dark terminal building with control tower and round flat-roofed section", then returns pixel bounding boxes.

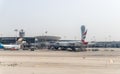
[0,29,60,44]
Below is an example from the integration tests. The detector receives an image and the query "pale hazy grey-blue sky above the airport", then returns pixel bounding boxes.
[0,0,120,41]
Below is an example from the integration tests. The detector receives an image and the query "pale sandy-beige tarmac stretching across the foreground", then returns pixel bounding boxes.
[0,48,120,74]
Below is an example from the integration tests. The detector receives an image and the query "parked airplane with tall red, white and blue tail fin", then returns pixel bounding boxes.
[49,25,88,51]
